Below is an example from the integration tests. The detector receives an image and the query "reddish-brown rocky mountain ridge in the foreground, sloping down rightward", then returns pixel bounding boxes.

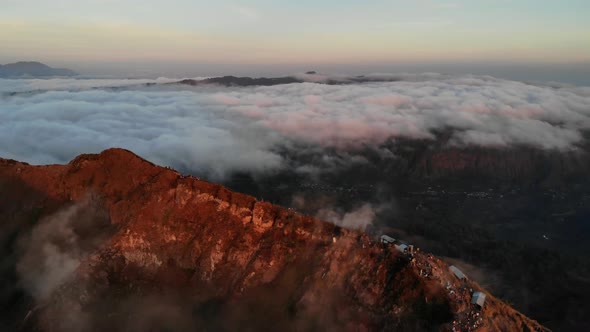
[0,149,541,331]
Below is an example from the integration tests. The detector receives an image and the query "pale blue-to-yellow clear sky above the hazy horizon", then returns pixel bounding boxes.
[0,0,590,73]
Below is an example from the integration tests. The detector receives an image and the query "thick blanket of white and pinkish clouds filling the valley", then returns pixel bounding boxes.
[0,74,590,177]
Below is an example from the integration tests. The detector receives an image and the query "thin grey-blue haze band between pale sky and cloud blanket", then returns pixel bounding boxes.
[0,57,590,86]
